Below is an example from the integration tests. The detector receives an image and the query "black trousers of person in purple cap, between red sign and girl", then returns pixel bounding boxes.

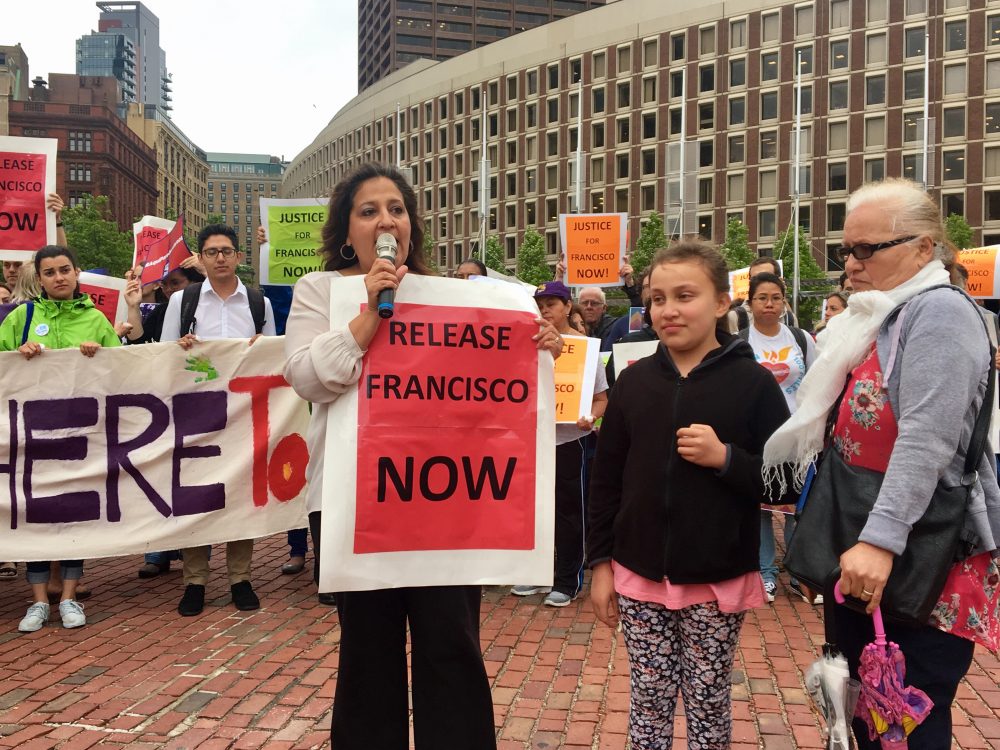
[552,440,586,596]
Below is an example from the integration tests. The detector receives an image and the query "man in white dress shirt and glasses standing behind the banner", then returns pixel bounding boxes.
[160,224,275,616]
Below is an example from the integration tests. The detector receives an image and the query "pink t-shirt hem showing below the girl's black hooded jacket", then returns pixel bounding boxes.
[611,560,766,613]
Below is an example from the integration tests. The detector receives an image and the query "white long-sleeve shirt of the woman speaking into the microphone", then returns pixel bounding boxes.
[282,271,365,513]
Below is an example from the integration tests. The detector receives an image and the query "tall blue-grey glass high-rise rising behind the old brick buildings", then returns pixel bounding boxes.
[76,2,172,113]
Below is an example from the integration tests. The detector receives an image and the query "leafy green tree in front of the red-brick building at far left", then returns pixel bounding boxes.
[62,195,134,278]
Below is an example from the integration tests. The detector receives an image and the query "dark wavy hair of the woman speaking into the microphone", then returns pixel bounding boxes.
[319,161,430,276]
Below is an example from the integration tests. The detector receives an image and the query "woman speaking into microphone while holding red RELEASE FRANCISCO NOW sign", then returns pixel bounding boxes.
[285,163,562,750]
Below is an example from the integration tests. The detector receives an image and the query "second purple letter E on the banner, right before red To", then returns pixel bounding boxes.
[171,391,228,516]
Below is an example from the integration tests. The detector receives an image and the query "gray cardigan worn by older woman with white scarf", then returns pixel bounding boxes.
[860,287,1000,555]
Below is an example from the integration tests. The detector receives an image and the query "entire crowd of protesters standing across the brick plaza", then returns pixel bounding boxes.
[0,170,1000,750]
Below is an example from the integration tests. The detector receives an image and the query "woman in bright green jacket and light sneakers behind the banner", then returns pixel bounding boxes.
[0,245,121,633]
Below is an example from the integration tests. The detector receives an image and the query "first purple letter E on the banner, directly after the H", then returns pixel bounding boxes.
[24,398,101,523]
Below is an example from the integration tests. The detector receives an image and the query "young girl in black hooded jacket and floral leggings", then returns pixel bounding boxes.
[587,239,788,750]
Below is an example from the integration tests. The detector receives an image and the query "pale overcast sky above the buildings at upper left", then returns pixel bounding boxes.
[0,0,358,160]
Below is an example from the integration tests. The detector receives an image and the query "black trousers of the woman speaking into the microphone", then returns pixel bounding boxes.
[330,586,496,750]
